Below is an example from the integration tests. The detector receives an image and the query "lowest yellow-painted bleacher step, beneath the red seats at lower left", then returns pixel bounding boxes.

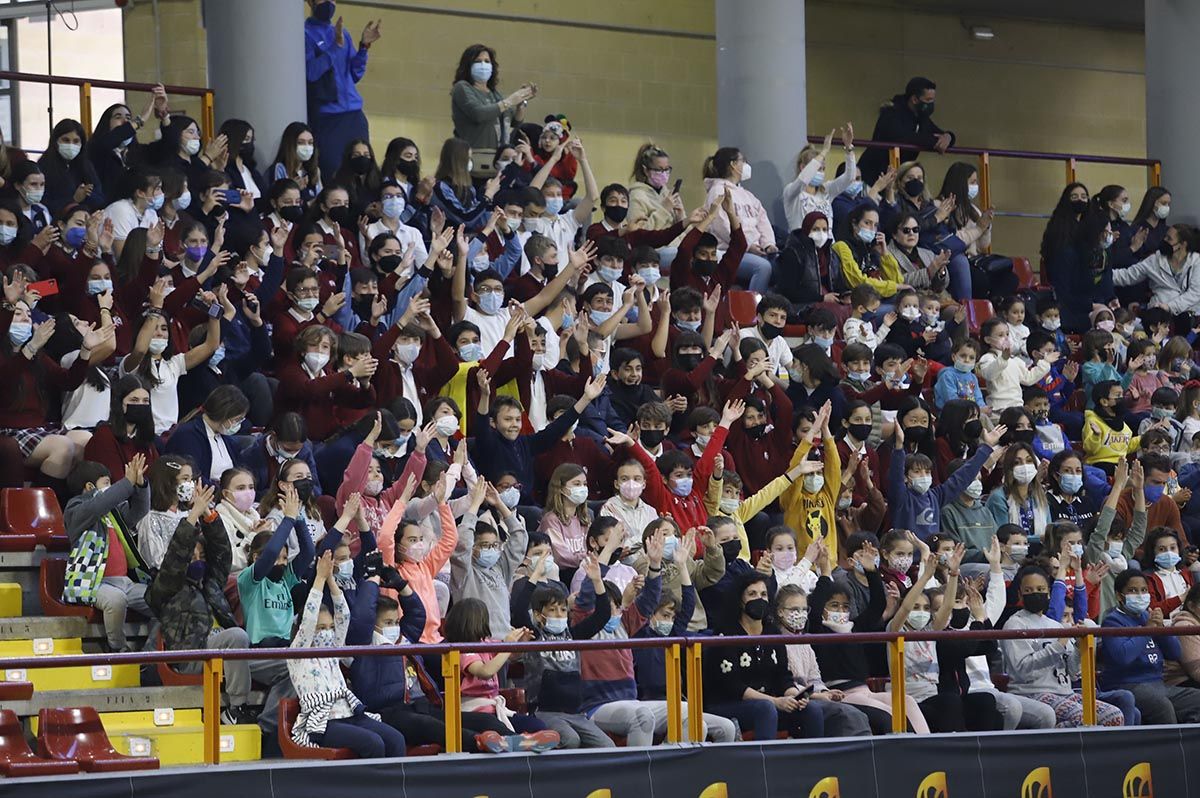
[30,707,263,767]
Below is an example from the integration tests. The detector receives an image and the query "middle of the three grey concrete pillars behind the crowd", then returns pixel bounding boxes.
[715,0,808,228]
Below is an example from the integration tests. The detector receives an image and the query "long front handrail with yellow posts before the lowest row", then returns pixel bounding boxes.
[0,626,1200,764]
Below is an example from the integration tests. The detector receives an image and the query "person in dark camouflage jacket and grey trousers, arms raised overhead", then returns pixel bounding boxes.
[146,486,256,725]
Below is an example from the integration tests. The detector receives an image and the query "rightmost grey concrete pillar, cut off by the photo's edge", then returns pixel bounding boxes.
[1130,0,1200,224]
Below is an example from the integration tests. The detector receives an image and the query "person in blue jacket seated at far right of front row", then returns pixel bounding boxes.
[1099,569,1200,725]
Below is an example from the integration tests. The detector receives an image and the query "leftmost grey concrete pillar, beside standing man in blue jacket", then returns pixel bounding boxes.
[204,0,307,168]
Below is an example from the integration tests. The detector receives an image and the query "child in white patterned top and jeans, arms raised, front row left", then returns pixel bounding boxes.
[287,552,406,757]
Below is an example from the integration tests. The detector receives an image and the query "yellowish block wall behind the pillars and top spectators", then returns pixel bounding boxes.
[125,0,1152,254]
